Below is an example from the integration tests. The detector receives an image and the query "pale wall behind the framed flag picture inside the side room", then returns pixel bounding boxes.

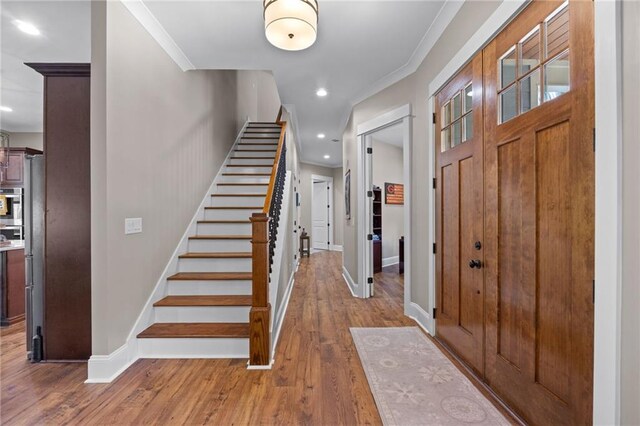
[372,138,404,262]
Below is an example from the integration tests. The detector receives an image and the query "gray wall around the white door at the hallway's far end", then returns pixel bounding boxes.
[299,163,344,245]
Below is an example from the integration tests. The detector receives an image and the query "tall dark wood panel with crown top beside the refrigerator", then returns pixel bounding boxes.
[26,63,91,361]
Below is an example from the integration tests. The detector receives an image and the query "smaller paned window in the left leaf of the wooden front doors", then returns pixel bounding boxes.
[440,83,473,152]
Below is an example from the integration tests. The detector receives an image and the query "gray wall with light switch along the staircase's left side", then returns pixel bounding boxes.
[91,2,279,355]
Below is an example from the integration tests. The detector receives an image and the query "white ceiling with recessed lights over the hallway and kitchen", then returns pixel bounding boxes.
[0,0,450,167]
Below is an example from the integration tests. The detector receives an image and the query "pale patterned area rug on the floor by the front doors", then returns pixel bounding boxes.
[351,327,510,425]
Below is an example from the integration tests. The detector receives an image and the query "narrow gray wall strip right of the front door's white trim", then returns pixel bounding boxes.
[620,1,640,425]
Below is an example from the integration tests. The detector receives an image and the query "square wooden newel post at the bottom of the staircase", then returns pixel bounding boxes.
[249,213,271,366]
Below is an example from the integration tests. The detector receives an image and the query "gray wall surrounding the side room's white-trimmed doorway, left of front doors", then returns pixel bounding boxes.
[343,1,501,310]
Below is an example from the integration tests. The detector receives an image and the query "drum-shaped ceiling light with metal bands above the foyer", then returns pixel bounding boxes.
[263,0,318,51]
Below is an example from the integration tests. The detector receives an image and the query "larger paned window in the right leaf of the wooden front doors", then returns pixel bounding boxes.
[498,2,570,123]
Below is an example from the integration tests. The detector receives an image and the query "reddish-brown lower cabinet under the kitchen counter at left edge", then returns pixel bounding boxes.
[0,249,25,326]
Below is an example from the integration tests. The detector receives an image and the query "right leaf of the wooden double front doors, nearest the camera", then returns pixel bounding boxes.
[483,1,595,425]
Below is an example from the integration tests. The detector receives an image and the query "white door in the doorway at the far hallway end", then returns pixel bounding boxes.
[311,175,333,251]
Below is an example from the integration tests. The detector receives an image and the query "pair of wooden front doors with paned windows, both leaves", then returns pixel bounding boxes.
[434,1,595,424]
